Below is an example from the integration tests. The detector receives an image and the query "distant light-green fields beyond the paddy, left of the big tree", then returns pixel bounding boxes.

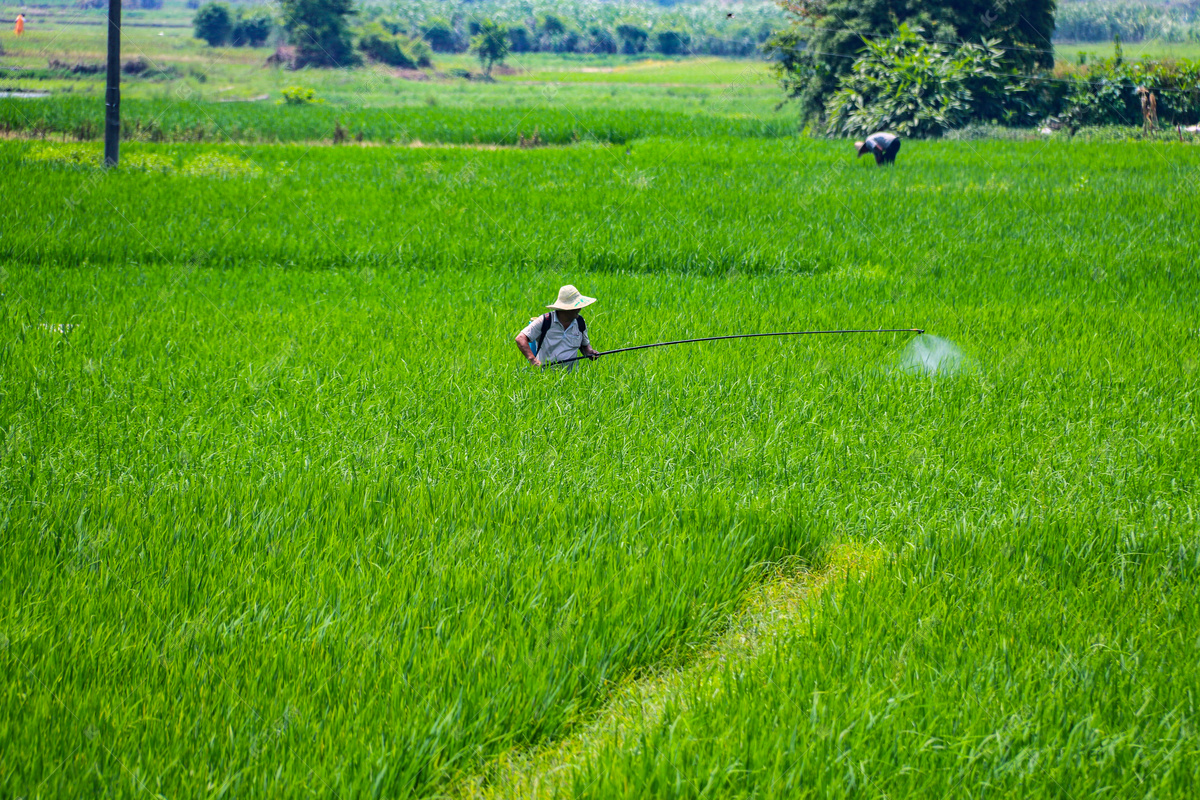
[0,10,782,144]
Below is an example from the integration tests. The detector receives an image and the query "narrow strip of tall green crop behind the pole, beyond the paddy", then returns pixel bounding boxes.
[0,95,797,145]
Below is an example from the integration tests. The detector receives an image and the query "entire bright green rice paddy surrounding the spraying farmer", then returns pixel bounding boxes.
[0,138,1200,798]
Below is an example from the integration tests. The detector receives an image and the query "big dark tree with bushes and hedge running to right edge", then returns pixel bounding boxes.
[767,0,1200,137]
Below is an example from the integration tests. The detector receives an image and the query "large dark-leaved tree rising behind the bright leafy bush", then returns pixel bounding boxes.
[767,0,1055,118]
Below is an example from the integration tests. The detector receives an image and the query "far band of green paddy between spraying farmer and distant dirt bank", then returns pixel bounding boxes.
[0,138,1200,284]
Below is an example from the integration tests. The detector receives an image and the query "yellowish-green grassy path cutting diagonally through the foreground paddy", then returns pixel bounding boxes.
[446,543,882,800]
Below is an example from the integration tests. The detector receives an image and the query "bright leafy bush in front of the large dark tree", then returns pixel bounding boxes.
[826,25,1026,137]
